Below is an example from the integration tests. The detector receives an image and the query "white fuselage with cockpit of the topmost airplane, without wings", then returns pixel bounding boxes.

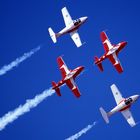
[58,17,87,36]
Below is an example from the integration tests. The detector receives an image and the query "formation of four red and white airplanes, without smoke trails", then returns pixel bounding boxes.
[48,7,140,127]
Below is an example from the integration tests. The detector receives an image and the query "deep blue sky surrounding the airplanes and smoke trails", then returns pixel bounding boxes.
[0,0,140,140]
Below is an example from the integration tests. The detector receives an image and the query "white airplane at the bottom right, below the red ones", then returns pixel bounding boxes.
[99,84,140,127]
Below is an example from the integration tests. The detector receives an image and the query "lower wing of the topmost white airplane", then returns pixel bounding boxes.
[70,31,82,47]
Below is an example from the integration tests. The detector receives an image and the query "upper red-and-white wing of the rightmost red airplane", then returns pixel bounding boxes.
[100,32,113,53]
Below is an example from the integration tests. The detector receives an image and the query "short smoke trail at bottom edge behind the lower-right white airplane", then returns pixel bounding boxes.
[65,121,97,140]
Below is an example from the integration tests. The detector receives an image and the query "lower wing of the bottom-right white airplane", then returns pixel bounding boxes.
[121,109,136,127]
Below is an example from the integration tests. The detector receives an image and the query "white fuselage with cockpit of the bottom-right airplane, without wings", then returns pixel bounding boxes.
[108,95,139,115]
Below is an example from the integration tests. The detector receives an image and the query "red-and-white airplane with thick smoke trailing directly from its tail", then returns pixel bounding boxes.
[52,56,84,98]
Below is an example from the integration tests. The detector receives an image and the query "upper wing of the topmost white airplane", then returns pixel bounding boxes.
[61,7,73,27]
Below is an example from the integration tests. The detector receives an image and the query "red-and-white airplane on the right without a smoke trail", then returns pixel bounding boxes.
[94,31,127,73]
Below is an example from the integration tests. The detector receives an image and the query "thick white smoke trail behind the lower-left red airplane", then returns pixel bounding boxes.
[0,88,55,131]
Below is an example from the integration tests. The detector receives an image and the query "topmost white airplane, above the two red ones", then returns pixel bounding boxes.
[48,7,88,47]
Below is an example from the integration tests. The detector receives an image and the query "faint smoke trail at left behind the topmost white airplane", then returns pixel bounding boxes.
[0,46,40,75]
